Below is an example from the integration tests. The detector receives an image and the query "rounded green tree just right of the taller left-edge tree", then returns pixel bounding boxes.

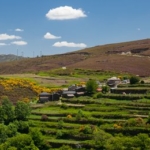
[15,101,31,120]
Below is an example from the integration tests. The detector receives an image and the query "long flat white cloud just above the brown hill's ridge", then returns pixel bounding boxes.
[53,41,87,48]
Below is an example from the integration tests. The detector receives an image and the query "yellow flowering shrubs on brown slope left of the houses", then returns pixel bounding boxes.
[0,78,60,102]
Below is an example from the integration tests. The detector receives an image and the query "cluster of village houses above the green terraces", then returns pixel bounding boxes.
[38,77,130,103]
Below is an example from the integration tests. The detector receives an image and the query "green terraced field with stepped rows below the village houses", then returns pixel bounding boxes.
[29,97,150,150]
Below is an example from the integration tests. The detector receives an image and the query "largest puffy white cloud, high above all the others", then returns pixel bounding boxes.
[46,6,86,20]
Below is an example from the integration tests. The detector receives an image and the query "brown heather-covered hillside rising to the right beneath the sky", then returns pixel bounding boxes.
[0,39,150,76]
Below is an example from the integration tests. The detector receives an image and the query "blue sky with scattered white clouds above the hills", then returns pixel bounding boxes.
[0,0,150,57]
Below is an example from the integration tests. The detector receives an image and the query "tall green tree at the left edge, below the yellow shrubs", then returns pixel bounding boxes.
[0,97,15,124]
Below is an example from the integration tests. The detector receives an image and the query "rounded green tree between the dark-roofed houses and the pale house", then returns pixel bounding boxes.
[86,79,98,94]
